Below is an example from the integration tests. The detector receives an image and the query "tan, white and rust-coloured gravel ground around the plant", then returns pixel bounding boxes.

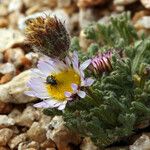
[0,0,150,150]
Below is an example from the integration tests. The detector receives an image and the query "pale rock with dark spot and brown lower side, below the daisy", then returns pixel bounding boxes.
[46,116,81,150]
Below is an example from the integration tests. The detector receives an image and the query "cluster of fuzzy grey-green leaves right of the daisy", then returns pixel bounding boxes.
[45,14,150,147]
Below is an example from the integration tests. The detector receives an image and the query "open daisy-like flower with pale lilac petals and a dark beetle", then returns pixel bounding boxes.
[25,52,94,110]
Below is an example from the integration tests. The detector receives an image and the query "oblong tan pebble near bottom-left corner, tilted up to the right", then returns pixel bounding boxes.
[8,133,27,149]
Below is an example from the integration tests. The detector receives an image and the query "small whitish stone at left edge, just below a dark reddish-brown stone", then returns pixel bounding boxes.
[0,115,15,127]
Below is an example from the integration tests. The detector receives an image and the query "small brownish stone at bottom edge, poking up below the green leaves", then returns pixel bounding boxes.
[80,137,98,150]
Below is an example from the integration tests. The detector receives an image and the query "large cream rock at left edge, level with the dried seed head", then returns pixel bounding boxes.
[0,28,25,52]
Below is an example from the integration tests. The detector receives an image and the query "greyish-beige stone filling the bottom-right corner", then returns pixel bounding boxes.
[129,134,150,150]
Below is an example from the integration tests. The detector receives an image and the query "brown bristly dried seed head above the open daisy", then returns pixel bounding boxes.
[25,16,70,58]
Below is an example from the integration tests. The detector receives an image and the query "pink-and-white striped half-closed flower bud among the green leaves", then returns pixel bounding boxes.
[90,51,112,73]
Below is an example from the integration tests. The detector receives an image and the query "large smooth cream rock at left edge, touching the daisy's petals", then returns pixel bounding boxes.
[0,70,37,104]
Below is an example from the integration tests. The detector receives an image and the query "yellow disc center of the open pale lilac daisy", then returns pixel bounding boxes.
[46,69,80,101]
